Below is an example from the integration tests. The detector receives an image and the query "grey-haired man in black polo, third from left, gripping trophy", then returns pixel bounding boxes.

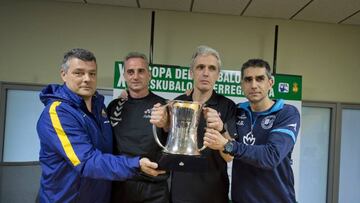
[150,46,235,203]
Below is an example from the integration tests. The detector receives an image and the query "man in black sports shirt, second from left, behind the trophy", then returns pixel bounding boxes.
[107,52,169,203]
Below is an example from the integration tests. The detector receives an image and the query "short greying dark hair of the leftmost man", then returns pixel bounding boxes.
[61,48,96,72]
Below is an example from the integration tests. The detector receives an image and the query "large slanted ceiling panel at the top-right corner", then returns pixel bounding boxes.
[294,0,360,23]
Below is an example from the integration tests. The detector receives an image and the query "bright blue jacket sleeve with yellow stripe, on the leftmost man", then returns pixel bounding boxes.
[37,102,139,180]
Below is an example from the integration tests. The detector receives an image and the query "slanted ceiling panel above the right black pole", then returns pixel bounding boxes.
[243,0,309,19]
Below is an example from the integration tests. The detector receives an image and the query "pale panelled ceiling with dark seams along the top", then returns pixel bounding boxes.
[56,0,360,25]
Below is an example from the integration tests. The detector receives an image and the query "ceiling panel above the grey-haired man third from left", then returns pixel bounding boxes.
[192,0,249,15]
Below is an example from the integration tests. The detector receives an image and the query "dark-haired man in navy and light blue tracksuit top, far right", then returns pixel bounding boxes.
[204,59,300,203]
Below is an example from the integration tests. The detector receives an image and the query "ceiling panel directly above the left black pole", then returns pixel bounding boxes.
[139,0,191,11]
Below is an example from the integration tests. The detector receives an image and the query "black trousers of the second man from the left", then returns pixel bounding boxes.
[111,180,169,203]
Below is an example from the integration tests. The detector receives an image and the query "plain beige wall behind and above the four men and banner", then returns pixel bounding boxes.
[0,0,360,102]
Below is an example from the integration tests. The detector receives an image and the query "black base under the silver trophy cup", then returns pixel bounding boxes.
[158,152,209,173]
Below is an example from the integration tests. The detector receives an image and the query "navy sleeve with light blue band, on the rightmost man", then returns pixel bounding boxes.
[234,106,300,169]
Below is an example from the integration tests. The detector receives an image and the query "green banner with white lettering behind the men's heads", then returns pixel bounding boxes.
[114,61,301,100]
